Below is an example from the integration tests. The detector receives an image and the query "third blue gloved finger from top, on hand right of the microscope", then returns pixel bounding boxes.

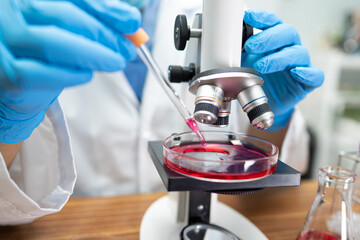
[253,45,311,74]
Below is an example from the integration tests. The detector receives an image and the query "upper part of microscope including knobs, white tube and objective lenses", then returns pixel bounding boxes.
[168,0,274,130]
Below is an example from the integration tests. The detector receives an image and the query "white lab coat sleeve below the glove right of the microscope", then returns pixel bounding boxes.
[279,108,310,173]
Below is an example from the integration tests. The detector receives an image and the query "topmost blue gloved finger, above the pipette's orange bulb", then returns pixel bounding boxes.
[67,0,141,34]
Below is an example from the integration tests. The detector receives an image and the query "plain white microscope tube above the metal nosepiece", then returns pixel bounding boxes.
[200,0,244,72]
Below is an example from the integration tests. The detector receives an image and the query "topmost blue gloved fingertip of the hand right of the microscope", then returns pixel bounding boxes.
[244,9,282,30]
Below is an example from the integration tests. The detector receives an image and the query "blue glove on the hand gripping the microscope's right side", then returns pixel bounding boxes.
[242,10,324,131]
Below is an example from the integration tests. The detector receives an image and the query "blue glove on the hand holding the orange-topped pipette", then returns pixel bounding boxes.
[0,0,141,143]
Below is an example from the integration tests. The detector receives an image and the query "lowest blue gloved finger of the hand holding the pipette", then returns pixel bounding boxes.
[16,27,126,72]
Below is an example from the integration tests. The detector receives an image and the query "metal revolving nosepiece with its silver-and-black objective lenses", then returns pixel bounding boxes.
[189,68,274,129]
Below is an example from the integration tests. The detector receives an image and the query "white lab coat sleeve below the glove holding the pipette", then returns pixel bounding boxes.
[0,101,76,225]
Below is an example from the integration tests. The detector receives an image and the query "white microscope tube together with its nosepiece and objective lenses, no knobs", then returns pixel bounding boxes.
[193,0,274,129]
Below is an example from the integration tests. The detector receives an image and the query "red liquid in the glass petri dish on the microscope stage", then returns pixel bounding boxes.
[164,142,276,181]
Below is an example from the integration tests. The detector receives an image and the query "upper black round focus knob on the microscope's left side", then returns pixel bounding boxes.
[174,14,191,50]
